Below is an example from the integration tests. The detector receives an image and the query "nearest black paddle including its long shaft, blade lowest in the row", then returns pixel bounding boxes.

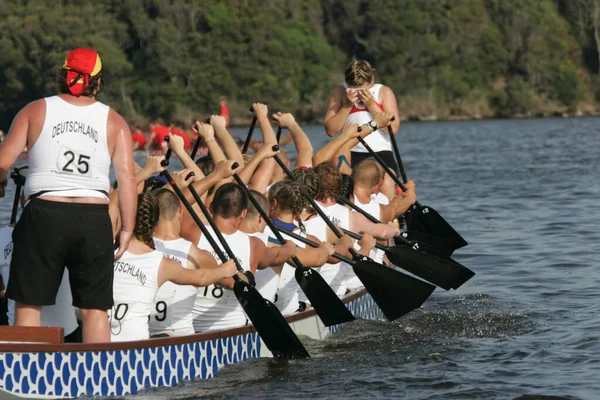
[161,153,310,359]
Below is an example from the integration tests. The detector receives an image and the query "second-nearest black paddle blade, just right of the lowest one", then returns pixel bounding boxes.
[296,267,355,326]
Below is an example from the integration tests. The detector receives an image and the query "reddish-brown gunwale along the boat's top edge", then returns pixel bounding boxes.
[0,288,367,353]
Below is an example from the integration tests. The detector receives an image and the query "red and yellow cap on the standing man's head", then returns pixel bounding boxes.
[63,48,102,97]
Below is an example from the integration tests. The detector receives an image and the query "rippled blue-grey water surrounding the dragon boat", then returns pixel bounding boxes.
[0,118,600,400]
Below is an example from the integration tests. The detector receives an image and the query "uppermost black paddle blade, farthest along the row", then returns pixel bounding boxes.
[404,203,468,248]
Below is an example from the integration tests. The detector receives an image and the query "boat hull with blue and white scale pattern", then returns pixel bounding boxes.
[0,290,383,399]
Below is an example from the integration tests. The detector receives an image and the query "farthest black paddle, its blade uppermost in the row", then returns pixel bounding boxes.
[357,127,468,249]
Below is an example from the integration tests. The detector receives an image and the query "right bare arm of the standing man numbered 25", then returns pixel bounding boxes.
[107,109,137,259]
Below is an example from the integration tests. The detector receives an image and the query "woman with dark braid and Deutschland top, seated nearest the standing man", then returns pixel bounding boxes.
[108,193,237,342]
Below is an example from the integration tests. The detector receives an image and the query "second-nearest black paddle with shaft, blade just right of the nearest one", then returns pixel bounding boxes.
[233,173,355,326]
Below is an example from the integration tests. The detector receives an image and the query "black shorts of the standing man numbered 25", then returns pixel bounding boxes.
[6,198,114,310]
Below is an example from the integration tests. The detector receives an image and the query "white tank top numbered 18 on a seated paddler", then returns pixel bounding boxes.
[194,227,250,332]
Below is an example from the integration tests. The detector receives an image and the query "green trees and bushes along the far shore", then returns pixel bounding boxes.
[0,0,600,130]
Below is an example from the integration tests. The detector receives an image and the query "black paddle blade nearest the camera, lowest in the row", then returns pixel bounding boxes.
[233,281,310,359]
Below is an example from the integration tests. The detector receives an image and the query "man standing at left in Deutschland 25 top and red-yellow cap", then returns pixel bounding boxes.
[0,48,137,343]
